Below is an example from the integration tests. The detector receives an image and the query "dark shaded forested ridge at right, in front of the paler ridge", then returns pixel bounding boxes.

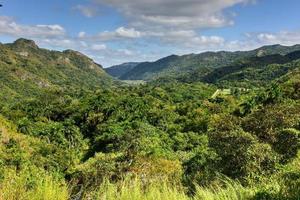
[199,51,300,87]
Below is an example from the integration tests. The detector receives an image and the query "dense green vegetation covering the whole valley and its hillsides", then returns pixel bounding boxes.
[0,39,300,200]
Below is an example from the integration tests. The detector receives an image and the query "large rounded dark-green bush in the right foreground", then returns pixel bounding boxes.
[210,129,276,180]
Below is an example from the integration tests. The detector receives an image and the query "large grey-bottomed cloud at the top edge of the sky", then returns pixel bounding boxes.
[94,0,253,28]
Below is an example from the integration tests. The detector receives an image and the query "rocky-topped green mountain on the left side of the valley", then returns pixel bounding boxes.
[0,39,112,103]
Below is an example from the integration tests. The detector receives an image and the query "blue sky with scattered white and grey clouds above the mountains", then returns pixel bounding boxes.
[0,0,300,67]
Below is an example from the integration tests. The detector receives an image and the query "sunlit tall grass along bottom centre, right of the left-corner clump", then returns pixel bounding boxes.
[84,179,255,200]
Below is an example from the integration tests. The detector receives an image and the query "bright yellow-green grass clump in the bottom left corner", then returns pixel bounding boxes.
[0,169,69,200]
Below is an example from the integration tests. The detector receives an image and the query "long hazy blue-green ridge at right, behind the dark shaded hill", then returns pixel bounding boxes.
[119,45,300,80]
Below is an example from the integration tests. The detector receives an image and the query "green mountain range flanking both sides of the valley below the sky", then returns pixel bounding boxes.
[0,38,300,102]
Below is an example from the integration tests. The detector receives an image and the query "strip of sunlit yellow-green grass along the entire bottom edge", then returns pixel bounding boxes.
[0,169,300,200]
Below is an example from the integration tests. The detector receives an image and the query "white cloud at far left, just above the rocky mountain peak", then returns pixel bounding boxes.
[0,16,65,38]
